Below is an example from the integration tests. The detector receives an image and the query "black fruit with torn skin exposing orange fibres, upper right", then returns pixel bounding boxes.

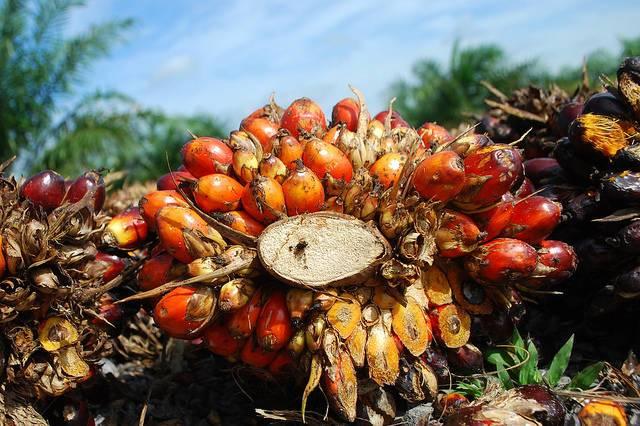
[569,114,630,158]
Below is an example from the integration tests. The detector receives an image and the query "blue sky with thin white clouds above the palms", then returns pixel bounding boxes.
[66,0,640,126]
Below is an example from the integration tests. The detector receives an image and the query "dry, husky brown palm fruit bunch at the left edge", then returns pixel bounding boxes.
[0,162,138,424]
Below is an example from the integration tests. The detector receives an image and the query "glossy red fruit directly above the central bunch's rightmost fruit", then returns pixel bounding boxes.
[500,195,562,244]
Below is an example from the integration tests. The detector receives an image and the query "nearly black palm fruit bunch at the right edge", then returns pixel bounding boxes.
[484,57,640,361]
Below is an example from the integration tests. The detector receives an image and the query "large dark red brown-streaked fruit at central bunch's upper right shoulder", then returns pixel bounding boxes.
[455,145,523,211]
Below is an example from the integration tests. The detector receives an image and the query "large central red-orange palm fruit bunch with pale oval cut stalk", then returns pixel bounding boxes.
[107,89,576,423]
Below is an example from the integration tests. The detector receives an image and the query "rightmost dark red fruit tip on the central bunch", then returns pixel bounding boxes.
[523,240,578,288]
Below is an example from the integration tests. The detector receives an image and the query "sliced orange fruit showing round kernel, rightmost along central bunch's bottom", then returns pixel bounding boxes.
[429,303,471,348]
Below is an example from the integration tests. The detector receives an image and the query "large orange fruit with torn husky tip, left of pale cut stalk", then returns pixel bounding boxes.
[156,206,226,263]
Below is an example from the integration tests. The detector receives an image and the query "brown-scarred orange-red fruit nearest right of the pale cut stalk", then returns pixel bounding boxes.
[436,210,486,257]
